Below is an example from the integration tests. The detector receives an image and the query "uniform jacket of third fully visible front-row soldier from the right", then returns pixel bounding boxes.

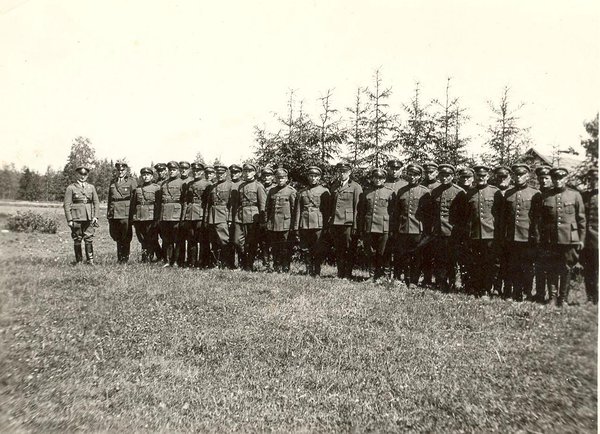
[465,184,503,240]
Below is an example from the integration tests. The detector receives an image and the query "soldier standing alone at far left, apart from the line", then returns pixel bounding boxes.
[64,166,100,265]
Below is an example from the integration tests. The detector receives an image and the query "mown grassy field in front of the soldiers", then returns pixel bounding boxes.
[0,204,598,432]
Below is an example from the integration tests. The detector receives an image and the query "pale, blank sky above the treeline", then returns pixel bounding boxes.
[0,0,600,171]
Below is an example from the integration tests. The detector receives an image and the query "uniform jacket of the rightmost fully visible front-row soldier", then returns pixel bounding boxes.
[540,188,586,244]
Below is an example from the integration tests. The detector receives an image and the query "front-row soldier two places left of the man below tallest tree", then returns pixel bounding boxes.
[293,166,331,276]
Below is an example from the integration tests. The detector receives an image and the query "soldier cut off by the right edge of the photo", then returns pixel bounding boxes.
[581,168,598,304]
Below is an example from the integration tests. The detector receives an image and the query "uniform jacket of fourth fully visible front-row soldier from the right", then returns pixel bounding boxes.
[428,184,467,237]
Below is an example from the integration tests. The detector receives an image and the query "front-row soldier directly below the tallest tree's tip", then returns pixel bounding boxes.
[358,168,396,280]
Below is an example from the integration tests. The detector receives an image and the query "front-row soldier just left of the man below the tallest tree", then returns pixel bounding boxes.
[328,163,362,279]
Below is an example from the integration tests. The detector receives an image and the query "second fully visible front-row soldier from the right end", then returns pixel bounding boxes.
[502,164,542,301]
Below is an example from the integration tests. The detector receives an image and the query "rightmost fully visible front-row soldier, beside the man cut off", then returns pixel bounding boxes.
[540,167,586,306]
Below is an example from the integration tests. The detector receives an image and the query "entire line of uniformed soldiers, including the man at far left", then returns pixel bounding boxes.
[64,160,598,306]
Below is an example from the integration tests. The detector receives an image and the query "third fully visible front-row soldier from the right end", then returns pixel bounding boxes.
[465,165,503,296]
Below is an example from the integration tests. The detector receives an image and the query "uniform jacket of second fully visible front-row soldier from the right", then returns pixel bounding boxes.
[502,185,542,243]
